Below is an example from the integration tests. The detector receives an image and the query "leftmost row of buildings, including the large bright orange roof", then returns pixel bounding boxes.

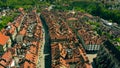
[0,10,24,54]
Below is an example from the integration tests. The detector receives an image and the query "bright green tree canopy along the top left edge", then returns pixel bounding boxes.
[0,0,39,8]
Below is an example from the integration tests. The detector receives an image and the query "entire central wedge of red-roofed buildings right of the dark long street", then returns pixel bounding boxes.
[42,10,91,68]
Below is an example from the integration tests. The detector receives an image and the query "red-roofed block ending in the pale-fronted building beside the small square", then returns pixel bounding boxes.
[45,11,102,52]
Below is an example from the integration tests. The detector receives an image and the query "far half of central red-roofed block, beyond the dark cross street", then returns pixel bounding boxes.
[41,11,73,41]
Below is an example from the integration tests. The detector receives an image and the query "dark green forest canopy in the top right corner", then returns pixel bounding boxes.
[70,1,120,24]
